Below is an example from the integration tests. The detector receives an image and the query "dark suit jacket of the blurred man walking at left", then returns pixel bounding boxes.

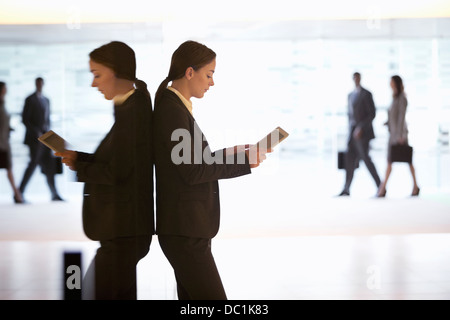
[22,92,50,145]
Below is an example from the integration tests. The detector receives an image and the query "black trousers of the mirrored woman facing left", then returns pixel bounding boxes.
[82,235,152,300]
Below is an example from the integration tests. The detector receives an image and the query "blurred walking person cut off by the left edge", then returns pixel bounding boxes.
[0,82,23,203]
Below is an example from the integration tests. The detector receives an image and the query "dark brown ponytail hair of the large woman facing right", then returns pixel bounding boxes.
[155,40,216,105]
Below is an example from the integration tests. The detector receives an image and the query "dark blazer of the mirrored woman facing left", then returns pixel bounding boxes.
[76,90,154,240]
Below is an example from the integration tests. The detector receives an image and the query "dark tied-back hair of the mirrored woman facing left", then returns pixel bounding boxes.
[89,41,150,97]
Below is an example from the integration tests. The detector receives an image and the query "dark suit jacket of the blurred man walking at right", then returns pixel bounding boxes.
[348,88,376,141]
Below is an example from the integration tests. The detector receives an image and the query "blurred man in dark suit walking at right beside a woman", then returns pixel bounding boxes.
[340,72,381,196]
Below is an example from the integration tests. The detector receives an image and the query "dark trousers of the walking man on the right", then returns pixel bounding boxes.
[344,137,381,192]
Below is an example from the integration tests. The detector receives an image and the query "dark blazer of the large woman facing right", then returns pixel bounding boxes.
[153,89,251,239]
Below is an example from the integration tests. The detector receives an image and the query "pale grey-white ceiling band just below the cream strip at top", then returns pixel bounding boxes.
[0,18,450,44]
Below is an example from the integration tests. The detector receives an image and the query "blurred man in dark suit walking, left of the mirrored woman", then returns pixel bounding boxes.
[19,78,63,201]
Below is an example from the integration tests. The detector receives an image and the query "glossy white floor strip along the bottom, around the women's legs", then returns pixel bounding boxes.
[0,234,450,300]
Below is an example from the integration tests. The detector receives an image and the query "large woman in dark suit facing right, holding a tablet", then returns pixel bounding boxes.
[153,41,267,300]
